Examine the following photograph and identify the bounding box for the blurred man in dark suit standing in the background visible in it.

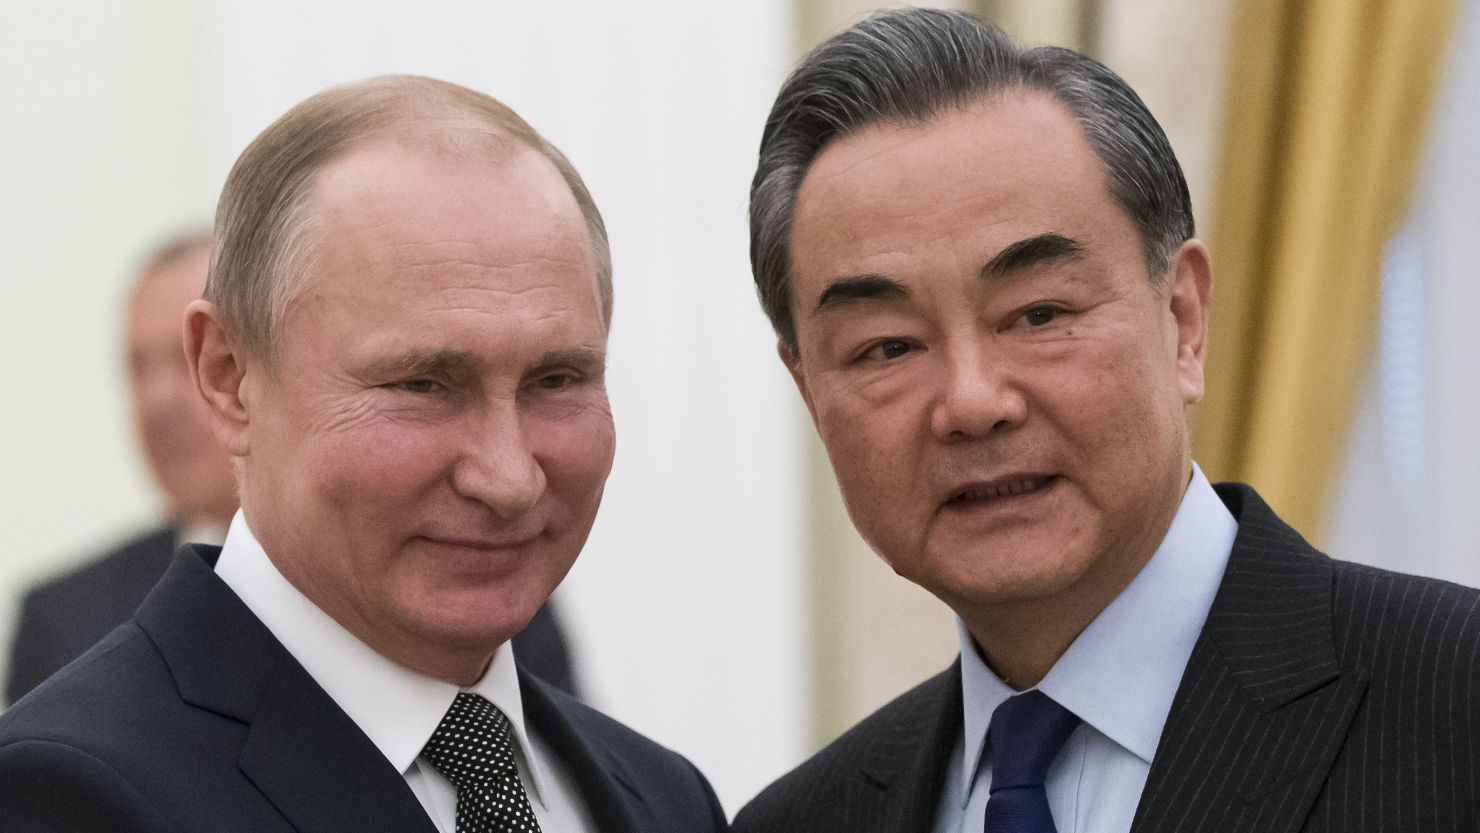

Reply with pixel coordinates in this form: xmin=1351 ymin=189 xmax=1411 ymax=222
xmin=4 ymin=234 xmax=576 ymax=703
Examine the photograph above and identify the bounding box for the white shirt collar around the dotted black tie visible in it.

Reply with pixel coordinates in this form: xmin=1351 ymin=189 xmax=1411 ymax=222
xmin=216 ymin=510 xmax=552 ymax=806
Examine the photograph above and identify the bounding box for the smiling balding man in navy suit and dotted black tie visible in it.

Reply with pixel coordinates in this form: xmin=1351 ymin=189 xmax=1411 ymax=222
xmin=0 ymin=77 xmax=725 ymax=833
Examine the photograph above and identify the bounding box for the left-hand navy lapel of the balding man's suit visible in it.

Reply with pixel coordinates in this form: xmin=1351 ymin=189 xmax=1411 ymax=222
xmin=138 ymin=547 xmax=435 ymax=833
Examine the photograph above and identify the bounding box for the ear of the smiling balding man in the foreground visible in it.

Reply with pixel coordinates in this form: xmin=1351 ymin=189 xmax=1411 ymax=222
xmin=185 ymin=300 xmax=249 ymax=457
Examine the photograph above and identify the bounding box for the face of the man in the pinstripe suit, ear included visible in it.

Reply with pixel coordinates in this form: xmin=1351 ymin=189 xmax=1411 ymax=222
xmin=783 ymin=93 xmax=1209 ymax=620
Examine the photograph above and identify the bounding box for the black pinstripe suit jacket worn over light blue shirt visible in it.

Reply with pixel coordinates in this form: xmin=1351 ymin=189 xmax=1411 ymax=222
xmin=734 ymin=484 xmax=1480 ymax=833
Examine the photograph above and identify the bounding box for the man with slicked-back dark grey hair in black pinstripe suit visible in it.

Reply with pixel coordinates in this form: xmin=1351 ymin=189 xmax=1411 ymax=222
xmin=734 ymin=9 xmax=1480 ymax=833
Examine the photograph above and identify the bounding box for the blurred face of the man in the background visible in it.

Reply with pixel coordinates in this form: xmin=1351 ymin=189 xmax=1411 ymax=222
xmin=126 ymin=247 xmax=237 ymax=524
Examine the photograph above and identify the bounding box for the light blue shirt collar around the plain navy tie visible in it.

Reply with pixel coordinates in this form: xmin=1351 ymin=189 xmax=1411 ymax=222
xmin=958 ymin=463 xmax=1239 ymax=795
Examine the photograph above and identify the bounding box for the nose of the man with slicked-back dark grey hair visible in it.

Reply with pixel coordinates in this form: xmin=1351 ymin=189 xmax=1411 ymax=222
xmin=931 ymin=343 xmax=1027 ymax=442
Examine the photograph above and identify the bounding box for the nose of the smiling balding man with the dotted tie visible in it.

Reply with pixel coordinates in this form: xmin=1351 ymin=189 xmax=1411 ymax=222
xmin=453 ymin=401 xmax=545 ymax=519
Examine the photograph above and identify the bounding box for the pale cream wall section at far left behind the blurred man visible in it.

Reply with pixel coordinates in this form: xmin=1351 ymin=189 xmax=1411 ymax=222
xmin=0 ymin=0 xmax=212 ymax=673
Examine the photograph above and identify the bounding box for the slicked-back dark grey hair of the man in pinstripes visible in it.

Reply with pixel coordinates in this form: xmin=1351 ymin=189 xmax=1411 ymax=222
xmin=750 ymin=9 xmax=1193 ymax=349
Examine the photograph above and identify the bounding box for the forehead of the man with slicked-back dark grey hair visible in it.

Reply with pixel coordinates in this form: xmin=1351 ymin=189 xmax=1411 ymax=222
xmin=792 ymin=90 xmax=1125 ymax=280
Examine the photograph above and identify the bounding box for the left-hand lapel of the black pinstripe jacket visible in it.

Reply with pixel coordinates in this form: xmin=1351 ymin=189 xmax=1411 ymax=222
xmin=842 ymin=660 xmax=962 ymax=833
